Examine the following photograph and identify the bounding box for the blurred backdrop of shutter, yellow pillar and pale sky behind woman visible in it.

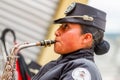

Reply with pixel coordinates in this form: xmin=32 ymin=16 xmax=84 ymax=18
xmin=0 ymin=0 xmax=120 ymax=80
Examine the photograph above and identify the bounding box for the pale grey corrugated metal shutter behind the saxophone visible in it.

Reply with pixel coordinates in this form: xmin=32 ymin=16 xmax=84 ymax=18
xmin=0 ymin=0 xmax=59 ymax=60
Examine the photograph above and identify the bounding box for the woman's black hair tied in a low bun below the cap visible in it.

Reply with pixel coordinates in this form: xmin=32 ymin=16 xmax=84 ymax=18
xmin=80 ymin=24 xmax=110 ymax=55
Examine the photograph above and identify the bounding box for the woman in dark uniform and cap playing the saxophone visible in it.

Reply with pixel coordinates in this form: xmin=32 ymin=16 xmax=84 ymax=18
xmin=32 ymin=2 xmax=110 ymax=80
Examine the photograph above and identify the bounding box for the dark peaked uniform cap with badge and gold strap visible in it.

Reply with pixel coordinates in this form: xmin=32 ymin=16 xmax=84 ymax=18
xmin=54 ymin=3 xmax=106 ymax=31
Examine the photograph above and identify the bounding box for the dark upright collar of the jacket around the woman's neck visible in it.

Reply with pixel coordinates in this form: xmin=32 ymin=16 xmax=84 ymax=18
xmin=57 ymin=49 xmax=94 ymax=63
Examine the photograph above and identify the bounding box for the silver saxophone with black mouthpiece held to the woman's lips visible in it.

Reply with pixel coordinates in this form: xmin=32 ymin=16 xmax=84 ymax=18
xmin=0 ymin=40 xmax=55 ymax=80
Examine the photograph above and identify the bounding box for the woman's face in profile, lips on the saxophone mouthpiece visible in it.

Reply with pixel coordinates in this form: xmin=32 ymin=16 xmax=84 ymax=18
xmin=54 ymin=23 xmax=88 ymax=54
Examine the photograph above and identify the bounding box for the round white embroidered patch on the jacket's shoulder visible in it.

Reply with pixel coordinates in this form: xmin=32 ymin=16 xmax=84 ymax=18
xmin=72 ymin=68 xmax=91 ymax=80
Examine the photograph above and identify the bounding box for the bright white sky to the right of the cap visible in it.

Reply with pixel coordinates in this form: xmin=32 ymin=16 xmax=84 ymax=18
xmin=88 ymin=0 xmax=120 ymax=34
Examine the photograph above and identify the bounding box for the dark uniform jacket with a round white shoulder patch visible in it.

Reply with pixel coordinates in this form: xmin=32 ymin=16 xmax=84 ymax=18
xmin=32 ymin=49 xmax=102 ymax=80
